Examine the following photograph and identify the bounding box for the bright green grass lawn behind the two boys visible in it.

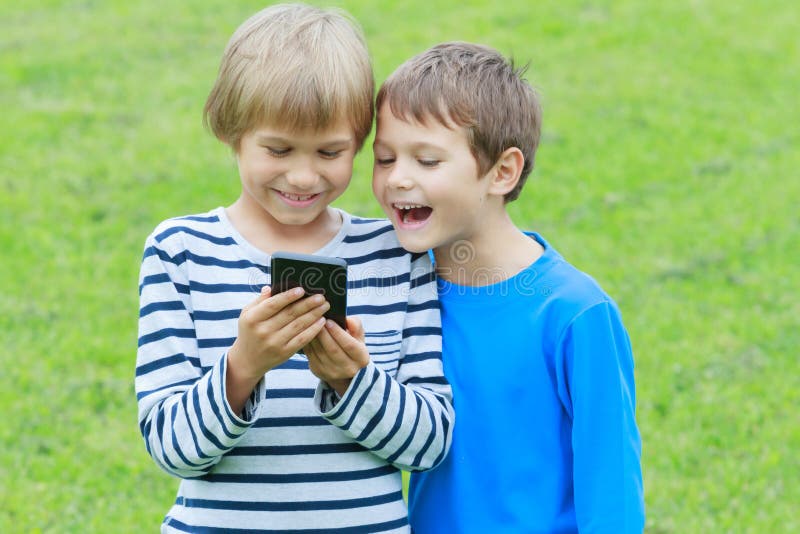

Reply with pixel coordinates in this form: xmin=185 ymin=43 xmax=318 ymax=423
xmin=0 ymin=0 xmax=800 ymax=534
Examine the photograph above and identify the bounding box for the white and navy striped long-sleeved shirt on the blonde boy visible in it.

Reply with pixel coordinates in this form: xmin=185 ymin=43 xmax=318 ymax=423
xmin=136 ymin=208 xmax=454 ymax=533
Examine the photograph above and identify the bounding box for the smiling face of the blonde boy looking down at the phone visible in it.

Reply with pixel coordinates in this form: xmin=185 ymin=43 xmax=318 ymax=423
xmin=236 ymin=121 xmax=356 ymax=231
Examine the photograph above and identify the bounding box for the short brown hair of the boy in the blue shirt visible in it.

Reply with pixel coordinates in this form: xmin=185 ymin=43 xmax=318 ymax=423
xmin=376 ymin=42 xmax=542 ymax=202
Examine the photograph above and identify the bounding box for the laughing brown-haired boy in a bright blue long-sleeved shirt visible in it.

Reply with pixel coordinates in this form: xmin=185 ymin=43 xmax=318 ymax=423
xmin=373 ymin=43 xmax=644 ymax=534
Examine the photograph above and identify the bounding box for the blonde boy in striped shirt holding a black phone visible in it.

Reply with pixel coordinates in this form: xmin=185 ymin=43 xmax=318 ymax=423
xmin=136 ymin=4 xmax=453 ymax=532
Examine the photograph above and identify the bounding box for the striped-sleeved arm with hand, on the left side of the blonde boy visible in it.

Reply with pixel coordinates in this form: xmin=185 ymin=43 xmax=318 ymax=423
xmin=136 ymin=238 xmax=327 ymax=477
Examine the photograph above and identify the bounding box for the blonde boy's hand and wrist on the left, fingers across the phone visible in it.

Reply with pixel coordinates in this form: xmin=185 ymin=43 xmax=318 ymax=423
xmin=226 ymin=286 xmax=330 ymax=413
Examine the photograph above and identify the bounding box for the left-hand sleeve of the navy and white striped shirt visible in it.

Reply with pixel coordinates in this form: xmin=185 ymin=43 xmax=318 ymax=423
xmin=135 ymin=236 xmax=258 ymax=478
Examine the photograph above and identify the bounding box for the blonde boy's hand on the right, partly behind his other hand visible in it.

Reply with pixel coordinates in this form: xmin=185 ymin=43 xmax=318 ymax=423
xmin=303 ymin=317 xmax=369 ymax=396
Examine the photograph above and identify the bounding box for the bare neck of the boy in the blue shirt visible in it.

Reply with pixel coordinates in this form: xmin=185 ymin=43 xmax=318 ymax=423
xmin=433 ymin=209 xmax=544 ymax=286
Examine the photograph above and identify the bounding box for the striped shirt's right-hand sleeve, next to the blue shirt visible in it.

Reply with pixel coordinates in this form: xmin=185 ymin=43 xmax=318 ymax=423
xmin=315 ymin=255 xmax=455 ymax=471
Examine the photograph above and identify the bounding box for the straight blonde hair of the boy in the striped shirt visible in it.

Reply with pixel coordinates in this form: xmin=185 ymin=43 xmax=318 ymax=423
xmin=203 ymin=4 xmax=375 ymax=149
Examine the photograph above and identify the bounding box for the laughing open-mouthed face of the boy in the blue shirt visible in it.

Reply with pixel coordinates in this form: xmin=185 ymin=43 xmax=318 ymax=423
xmin=372 ymin=104 xmax=491 ymax=252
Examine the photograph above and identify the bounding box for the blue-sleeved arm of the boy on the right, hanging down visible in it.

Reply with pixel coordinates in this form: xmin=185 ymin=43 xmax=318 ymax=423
xmin=559 ymin=302 xmax=644 ymax=534
